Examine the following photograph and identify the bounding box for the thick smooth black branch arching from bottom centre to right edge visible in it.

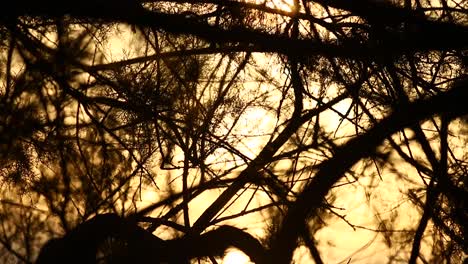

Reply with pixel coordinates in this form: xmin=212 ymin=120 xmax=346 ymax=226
xmin=270 ymin=77 xmax=468 ymax=263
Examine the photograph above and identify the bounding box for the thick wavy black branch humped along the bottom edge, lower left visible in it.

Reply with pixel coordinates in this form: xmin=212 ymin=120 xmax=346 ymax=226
xmin=36 ymin=214 xmax=266 ymax=264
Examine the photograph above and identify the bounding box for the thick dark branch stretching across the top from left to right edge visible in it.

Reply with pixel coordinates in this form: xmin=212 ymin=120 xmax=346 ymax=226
xmin=2 ymin=0 xmax=468 ymax=60
